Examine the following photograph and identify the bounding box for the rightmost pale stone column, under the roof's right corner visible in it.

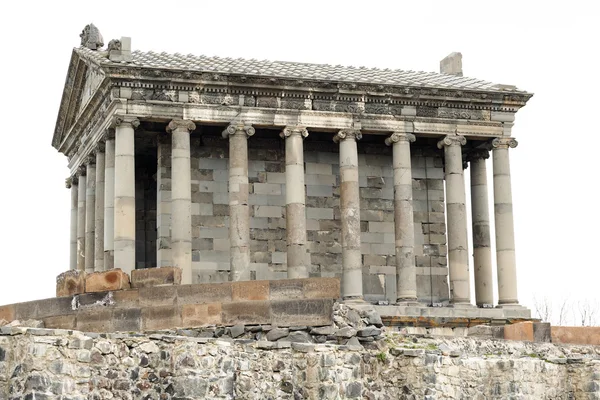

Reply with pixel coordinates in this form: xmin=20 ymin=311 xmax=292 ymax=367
xmin=492 ymin=137 xmax=519 ymax=306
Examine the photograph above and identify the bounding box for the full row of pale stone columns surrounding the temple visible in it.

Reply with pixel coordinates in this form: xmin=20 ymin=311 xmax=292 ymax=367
xmin=67 ymin=116 xmax=518 ymax=306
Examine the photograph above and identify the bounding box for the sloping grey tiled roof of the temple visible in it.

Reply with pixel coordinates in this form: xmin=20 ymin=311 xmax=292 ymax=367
xmin=75 ymin=47 xmax=526 ymax=93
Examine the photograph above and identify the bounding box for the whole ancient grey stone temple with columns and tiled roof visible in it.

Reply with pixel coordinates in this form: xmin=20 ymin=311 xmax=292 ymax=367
xmin=52 ymin=25 xmax=532 ymax=318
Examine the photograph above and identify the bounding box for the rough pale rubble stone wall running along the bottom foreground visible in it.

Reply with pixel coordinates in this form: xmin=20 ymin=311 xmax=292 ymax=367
xmin=0 ymin=327 xmax=600 ymax=400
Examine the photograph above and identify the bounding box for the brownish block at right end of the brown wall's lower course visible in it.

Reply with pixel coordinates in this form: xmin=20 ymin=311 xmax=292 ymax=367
xmin=271 ymin=299 xmax=334 ymax=326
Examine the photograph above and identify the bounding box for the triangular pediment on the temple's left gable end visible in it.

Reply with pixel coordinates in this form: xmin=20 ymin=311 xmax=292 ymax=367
xmin=52 ymin=50 xmax=105 ymax=151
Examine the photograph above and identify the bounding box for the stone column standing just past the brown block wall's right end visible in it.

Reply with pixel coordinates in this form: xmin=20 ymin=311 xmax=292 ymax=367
xmin=333 ymin=129 xmax=363 ymax=300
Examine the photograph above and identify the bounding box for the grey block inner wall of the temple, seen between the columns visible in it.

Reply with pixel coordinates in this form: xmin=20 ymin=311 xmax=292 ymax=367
xmin=157 ymin=127 xmax=449 ymax=303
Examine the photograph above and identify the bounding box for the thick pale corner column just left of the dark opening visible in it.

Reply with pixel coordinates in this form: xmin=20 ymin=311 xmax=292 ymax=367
xmin=114 ymin=116 xmax=140 ymax=274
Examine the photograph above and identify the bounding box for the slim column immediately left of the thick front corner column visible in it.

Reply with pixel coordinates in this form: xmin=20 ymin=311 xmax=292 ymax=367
xmin=104 ymin=128 xmax=115 ymax=271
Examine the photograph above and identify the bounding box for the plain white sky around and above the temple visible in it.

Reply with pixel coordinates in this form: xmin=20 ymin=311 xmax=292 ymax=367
xmin=0 ymin=0 xmax=600 ymax=324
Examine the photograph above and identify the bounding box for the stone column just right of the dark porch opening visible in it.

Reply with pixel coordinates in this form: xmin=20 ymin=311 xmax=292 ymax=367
xmin=167 ymin=119 xmax=196 ymax=284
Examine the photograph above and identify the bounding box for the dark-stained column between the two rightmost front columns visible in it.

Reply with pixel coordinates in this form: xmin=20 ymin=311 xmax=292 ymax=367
xmin=468 ymin=149 xmax=494 ymax=307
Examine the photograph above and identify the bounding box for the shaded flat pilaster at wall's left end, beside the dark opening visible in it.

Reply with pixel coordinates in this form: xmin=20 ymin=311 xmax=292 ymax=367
xmin=156 ymin=132 xmax=173 ymax=267
